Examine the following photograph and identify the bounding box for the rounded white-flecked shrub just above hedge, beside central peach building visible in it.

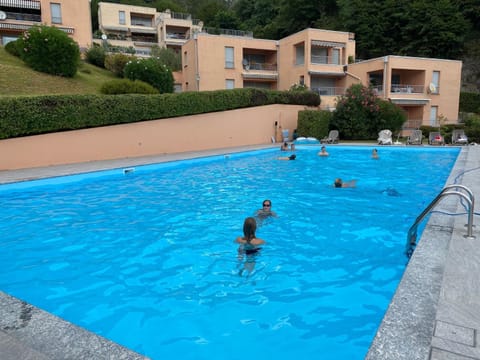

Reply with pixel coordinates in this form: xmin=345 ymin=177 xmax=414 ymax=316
xmin=124 ymin=58 xmax=173 ymax=94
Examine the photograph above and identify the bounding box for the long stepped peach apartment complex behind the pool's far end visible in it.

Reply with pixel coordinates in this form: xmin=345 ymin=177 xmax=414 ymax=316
xmin=182 ymin=29 xmax=462 ymax=128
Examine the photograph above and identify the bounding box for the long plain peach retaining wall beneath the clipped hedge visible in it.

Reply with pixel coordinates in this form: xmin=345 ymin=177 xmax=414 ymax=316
xmin=0 ymin=105 xmax=305 ymax=170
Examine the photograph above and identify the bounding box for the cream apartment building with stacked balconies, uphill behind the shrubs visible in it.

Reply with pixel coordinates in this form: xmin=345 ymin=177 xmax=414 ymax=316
xmin=94 ymin=2 xmax=203 ymax=56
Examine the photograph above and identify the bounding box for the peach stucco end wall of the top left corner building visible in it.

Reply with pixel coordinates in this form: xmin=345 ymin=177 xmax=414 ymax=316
xmin=40 ymin=0 xmax=92 ymax=48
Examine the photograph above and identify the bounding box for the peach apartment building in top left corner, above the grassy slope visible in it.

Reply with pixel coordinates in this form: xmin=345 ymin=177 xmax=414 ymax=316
xmin=0 ymin=0 xmax=92 ymax=49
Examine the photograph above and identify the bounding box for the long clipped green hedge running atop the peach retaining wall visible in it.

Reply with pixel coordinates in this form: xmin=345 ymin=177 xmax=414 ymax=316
xmin=0 ymin=89 xmax=320 ymax=139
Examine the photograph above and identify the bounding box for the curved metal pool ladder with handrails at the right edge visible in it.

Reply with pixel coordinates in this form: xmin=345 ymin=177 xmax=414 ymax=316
xmin=405 ymin=185 xmax=475 ymax=258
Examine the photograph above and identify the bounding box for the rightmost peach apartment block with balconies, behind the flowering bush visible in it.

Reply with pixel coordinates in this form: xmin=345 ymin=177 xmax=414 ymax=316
xmin=346 ymin=55 xmax=462 ymax=129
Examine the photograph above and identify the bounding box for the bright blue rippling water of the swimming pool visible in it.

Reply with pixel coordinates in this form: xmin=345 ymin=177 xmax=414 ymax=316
xmin=0 ymin=146 xmax=459 ymax=360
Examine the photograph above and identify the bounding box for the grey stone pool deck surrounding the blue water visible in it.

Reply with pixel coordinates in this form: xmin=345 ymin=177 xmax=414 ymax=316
xmin=0 ymin=144 xmax=480 ymax=360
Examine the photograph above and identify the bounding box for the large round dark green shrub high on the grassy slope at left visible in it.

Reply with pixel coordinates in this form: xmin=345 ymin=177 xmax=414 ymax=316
xmin=17 ymin=25 xmax=80 ymax=77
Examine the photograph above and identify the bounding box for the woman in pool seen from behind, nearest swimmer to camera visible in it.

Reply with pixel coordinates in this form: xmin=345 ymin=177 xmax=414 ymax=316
xmin=235 ymin=217 xmax=265 ymax=275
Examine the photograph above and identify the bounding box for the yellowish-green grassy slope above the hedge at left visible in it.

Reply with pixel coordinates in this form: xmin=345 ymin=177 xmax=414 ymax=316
xmin=0 ymin=46 xmax=115 ymax=96
